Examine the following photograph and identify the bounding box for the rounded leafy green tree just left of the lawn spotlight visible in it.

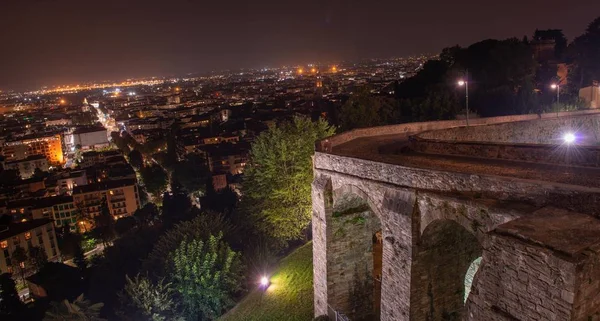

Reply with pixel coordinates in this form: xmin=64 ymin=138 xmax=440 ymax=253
xmin=170 ymin=234 xmax=241 ymax=320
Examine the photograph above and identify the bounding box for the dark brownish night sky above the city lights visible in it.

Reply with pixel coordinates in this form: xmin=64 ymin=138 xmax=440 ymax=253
xmin=0 ymin=0 xmax=600 ymax=89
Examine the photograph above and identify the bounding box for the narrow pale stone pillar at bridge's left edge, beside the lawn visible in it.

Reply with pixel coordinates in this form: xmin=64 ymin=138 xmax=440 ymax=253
xmin=312 ymin=176 xmax=332 ymax=317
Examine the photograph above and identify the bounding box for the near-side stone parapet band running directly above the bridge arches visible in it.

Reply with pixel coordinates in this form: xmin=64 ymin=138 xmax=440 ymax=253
xmin=314 ymin=152 xmax=600 ymax=216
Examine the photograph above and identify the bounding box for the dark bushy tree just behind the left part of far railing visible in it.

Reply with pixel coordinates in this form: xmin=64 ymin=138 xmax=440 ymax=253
xmin=339 ymin=87 xmax=400 ymax=130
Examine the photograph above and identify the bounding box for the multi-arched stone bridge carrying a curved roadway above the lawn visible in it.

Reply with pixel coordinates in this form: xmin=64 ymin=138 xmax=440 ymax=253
xmin=312 ymin=111 xmax=600 ymax=321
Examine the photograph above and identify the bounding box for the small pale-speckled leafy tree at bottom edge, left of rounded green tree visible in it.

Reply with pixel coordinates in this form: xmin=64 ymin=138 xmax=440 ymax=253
xmin=117 ymin=274 xmax=183 ymax=321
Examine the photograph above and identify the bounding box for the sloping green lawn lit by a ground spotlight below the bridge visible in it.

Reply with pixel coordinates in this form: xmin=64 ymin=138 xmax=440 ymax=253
xmin=219 ymin=242 xmax=313 ymax=321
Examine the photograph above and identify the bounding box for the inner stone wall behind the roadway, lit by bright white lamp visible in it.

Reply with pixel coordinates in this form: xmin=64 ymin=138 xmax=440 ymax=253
xmin=418 ymin=114 xmax=600 ymax=145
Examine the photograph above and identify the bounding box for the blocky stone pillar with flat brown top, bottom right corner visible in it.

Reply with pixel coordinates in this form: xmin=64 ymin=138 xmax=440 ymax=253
xmin=467 ymin=209 xmax=600 ymax=321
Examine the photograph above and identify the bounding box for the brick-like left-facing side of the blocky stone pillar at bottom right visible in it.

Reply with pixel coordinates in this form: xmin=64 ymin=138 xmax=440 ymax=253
xmin=467 ymin=231 xmax=575 ymax=321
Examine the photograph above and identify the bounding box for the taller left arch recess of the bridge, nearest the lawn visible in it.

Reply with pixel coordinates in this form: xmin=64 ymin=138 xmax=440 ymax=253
xmin=327 ymin=185 xmax=383 ymax=320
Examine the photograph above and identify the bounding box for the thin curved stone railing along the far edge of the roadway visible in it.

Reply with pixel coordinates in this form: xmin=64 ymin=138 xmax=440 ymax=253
xmin=315 ymin=109 xmax=600 ymax=153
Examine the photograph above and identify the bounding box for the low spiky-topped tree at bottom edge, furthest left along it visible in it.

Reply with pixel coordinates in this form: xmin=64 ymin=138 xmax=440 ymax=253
xmin=44 ymin=294 xmax=104 ymax=321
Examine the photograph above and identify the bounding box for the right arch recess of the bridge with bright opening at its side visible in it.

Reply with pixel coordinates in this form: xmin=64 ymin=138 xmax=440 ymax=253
xmin=410 ymin=219 xmax=482 ymax=321
